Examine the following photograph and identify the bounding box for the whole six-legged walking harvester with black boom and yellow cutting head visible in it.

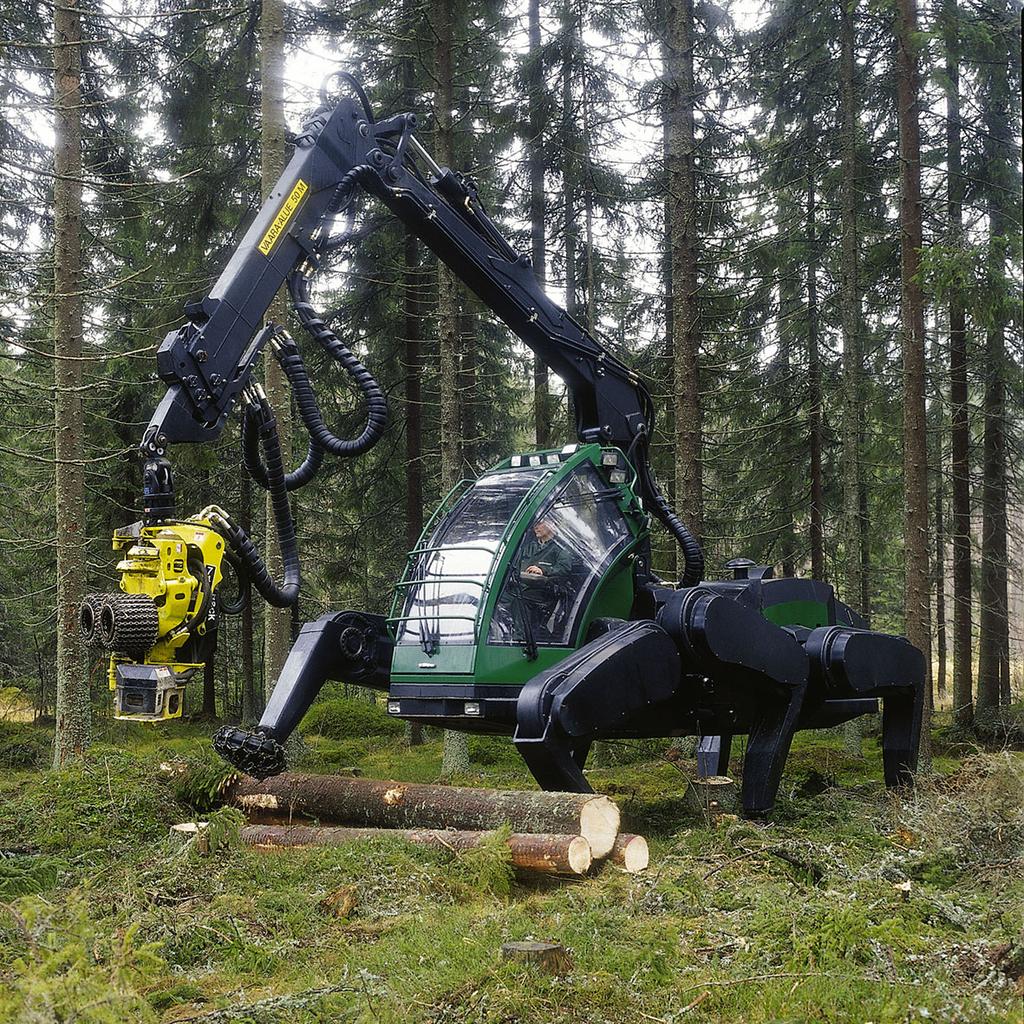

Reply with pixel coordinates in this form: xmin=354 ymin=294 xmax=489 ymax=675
xmin=81 ymin=73 xmax=925 ymax=816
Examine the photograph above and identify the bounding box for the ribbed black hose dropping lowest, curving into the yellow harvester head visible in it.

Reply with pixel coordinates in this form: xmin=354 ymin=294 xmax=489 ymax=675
xmin=218 ymin=394 xmax=301 ymax=608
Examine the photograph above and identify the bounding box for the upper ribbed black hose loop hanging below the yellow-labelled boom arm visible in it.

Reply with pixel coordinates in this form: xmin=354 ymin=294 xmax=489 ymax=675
xmin=278 ymin=270 xmax=387 ymax=456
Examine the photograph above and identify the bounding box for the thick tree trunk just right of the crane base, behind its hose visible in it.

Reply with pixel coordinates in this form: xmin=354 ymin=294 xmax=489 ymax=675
xmin=666 ymin=0 xmax=703 ymax=574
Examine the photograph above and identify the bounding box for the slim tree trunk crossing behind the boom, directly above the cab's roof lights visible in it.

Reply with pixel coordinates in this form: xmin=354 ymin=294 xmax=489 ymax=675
xmin=526 ymin=0 xmax=552 ymax=449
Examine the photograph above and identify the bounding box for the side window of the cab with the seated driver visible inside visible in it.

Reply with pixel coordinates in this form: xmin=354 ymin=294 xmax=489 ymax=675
xmin=487 ymin=463 xmax=632 ymax=646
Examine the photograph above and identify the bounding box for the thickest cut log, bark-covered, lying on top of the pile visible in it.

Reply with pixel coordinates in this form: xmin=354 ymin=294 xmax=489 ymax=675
xmin=224 ymin=773 xmax=618 ymax=857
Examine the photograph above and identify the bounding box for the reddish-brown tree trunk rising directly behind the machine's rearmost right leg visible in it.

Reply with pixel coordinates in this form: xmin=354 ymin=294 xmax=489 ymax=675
xmin=896 ymin=0 xmax=932 ymax=771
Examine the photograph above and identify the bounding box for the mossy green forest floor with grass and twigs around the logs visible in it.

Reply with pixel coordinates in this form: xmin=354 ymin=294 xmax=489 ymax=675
xmin=0 ymin=725 xmax=1024 ymax=1024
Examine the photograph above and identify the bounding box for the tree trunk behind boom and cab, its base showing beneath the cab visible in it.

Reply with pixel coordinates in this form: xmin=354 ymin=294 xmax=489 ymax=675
xmin=430 ymin=0 xmax=469 ymax=777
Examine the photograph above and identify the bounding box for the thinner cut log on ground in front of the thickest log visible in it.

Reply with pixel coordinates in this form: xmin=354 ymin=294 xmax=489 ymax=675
xmin=242 ymin=825 xmax=592 ymax=874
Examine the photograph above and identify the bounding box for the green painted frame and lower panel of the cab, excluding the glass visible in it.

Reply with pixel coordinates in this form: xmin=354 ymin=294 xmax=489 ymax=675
xmin=391 ymin=444 xmax=649 ymax=685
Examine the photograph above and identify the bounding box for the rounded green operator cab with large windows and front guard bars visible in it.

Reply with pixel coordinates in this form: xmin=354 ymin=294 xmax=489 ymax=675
xmin=388 ymin=444 xmax=649 ymax=732
